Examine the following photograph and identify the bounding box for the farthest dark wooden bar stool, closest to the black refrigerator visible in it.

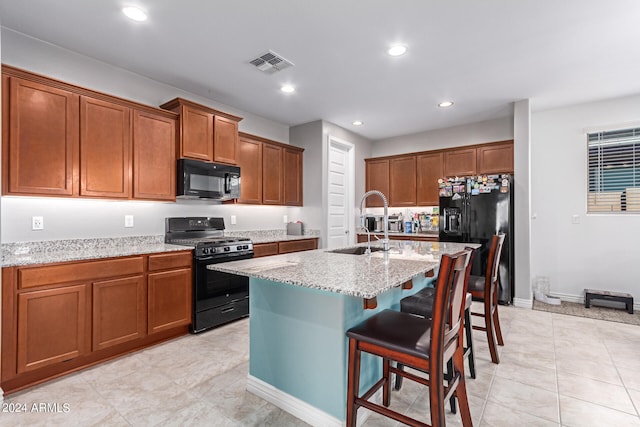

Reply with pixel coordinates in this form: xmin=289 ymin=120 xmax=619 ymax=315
xmin=468 ymin=234 xmax=505 ymax=363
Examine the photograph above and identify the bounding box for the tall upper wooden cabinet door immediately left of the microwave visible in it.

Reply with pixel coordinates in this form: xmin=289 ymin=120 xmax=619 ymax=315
xmin=133 ymin=110 xmax=176 ymax=201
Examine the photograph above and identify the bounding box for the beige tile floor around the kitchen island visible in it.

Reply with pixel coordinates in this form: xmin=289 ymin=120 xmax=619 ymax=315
xmin=0 ymin=307 xmax=640 ymax=427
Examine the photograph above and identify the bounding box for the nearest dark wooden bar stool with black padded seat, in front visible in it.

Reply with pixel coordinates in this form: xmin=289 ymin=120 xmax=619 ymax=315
xmin=346 ymin=251 xmax=472 ymax=427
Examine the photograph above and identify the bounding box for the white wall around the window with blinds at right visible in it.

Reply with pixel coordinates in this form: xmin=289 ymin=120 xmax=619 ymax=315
xmin=531 ymin=95 xmax=640 ymax=301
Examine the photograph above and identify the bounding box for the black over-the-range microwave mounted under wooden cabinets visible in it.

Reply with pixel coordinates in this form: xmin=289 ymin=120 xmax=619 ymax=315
xmin=176 ymin=159 xmax=240 ymax=201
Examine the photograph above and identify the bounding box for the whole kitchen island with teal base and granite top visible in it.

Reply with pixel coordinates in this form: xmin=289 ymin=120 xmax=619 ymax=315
xmin=208 ymin=241 xmax=476 ymax=426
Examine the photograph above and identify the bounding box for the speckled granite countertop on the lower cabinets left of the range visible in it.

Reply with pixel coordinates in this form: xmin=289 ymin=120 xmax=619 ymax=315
xmin=1 ymin=236 xmax=191 ymax=267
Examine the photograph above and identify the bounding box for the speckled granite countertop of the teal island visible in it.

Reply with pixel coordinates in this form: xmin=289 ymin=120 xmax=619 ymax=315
xmin=207 ymin=241 xmax=479 ymax=298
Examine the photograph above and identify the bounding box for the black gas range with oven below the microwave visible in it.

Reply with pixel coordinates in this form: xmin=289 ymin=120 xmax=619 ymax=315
xmin=164 ymin=217 xmax=253 ymax=333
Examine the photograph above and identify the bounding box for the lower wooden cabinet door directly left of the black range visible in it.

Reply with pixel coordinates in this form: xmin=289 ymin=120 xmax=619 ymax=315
xmin=147 ymin=268 xmax=193 ymax=334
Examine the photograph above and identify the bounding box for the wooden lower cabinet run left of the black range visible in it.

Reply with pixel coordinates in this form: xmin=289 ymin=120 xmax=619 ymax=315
xmin=0 ymin=250 xmax=193 ymax=393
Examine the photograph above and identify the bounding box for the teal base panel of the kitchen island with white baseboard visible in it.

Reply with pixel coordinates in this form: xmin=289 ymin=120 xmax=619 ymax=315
xmin=247 ymin=276 xmax=433 ymax=426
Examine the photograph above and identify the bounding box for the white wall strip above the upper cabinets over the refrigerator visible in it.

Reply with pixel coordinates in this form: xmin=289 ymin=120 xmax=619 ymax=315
xmin=371 ymin=117 xmax=513 ymax=157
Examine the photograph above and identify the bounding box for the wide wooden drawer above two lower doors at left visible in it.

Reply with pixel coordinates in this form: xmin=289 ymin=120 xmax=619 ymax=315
xmin=18 ymin=257 xmax=144 ymax=289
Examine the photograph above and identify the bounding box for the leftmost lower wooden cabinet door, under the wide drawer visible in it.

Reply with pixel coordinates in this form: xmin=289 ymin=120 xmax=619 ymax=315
xmin=17 ymin=285 xmax=90 ymax=373
